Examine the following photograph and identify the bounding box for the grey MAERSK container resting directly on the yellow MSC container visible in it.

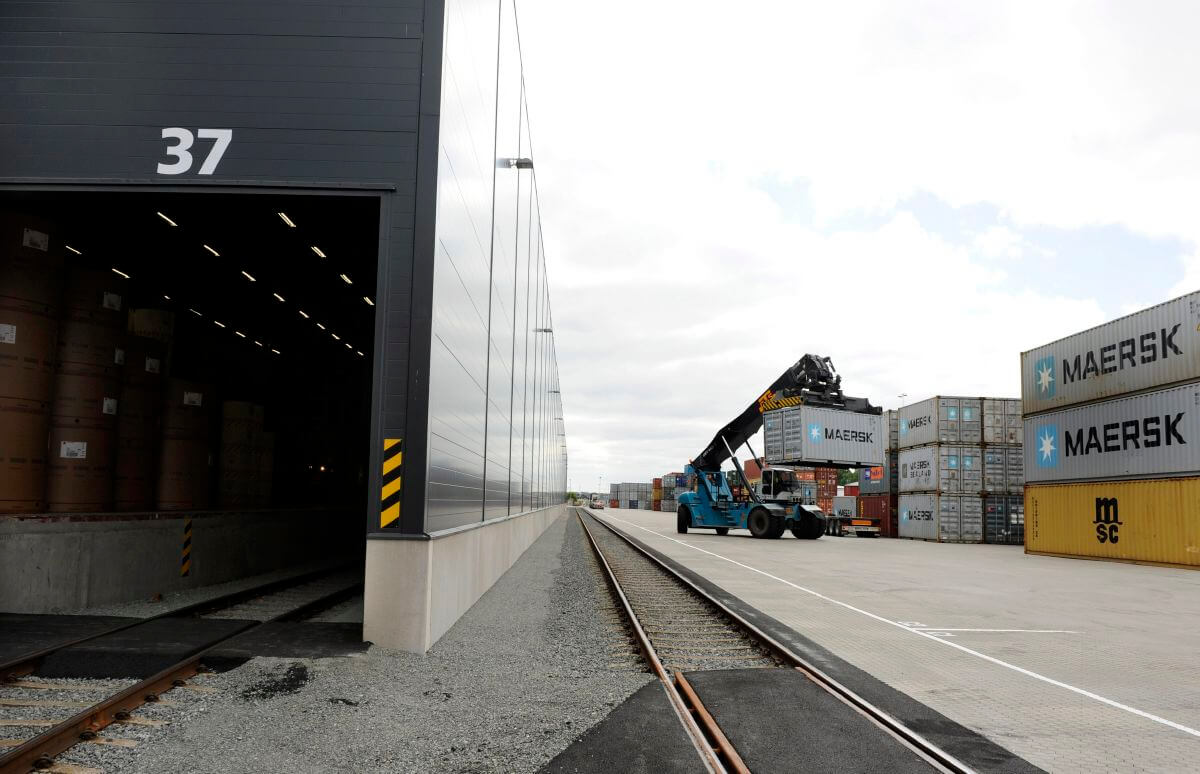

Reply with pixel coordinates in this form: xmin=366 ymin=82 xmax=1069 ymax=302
xmin=1025 ymin=382 xmax=1200 ymax=484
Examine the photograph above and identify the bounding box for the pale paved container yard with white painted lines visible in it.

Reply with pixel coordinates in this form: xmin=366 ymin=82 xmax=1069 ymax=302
xmin=596 ymin=510 xmax=1200 ymax=772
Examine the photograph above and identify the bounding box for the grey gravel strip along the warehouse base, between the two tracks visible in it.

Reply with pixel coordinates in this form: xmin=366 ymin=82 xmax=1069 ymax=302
xmin=110 ymin=516 xmax=652 ymax=774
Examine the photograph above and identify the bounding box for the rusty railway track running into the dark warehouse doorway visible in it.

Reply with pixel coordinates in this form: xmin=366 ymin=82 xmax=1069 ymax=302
xmin=0 ymin=568 xmax=362 ymax=774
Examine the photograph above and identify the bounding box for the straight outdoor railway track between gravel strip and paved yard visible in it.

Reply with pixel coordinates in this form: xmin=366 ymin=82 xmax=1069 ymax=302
xmin=576 ymin=509 xmax=972 ymax=774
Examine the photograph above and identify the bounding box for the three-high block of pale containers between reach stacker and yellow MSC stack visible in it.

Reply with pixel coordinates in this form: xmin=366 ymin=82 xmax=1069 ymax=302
xmin=895 ymin=395 xmax=1024 ymax=544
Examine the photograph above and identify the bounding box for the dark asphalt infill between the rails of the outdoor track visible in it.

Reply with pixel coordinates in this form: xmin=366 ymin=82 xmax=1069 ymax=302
xmin=684 ymin=670 xmax=935 ymax=774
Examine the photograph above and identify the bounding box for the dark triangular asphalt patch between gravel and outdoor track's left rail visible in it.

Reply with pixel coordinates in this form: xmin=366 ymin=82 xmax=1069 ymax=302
xmin=541 ymin=680 xmax=704 ymax=774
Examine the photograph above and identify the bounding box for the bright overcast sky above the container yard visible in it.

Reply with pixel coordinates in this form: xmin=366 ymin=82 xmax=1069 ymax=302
xmin=518 ymin=0 xmax=1200 ymax=491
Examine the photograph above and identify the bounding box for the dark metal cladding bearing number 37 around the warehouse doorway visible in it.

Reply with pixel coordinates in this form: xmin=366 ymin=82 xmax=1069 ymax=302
xmin=0 ymin=0 xmax=427 ymax=534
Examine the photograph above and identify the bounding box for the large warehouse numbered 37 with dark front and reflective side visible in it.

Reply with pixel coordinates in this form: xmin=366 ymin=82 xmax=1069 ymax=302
xmin=0 ymin=0 xmax=566 ymax=652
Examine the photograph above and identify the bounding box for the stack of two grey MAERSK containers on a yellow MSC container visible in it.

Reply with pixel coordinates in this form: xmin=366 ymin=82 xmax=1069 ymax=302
xmin=1021 ymin=292 xmax=1200 ymax=568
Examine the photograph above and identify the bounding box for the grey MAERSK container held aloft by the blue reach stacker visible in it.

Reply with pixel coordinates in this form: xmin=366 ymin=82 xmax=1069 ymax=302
xmin=762 ymin=406 xmax=887 ymax=468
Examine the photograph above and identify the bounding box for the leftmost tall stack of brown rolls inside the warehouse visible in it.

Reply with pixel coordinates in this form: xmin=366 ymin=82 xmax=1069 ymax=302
xmin=0 ymin=214 xmax=64 ymax=512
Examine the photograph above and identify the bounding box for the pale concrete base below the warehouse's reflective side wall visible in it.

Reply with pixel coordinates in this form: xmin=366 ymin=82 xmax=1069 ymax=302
xmin=362 ymin=505 xmax=566 ymax=653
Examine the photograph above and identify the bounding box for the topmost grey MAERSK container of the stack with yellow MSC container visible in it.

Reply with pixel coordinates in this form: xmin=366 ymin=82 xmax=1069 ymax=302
xmin=1021 ymin=292 xmax=1200 ymax=416
